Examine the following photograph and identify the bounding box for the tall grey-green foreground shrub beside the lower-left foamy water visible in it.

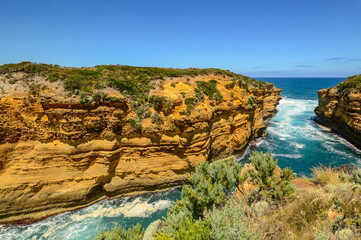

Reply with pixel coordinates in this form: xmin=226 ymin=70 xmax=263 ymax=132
xmin=162 ymin=161 xmax=244 ymax=237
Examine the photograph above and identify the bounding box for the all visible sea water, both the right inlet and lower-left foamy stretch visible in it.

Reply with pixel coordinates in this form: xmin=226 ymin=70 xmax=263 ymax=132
xmin=0 ymin=78 xmax=361 ymax=240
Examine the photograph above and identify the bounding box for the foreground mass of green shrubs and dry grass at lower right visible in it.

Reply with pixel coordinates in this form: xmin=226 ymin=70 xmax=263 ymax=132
xmin=91 ymin=152 xmax=361 ymax=240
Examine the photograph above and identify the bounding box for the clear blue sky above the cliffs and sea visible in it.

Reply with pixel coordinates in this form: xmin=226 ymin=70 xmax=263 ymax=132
xmin=0 ymin=0 xmax=361 ymax=77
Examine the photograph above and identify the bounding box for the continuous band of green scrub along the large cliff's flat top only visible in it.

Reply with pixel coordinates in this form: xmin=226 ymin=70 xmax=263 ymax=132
xmin=0 ymin=62 xmax=265 ymax=98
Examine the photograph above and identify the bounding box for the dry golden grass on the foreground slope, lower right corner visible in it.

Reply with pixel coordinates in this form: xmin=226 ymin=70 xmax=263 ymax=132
xmin=250 ymin=166 xmax=361 ymax=240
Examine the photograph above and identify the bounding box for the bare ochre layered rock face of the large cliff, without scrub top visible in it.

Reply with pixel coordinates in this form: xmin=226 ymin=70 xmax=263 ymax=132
xmin=0 ymin=63 xmax=281 ymax=222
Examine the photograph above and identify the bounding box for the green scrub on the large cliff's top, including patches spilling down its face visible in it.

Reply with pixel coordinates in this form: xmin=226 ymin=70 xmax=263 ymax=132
xmin=0 ymin=62 xmax=272 ymax=124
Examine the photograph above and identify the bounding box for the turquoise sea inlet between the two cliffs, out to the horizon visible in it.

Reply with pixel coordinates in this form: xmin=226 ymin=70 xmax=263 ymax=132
xmin=243 ymin=78 xmax=361 ymax=176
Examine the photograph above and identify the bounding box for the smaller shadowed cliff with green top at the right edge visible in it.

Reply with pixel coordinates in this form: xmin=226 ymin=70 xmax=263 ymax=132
xmin=315 ymin=75 xmax=361 ymax=148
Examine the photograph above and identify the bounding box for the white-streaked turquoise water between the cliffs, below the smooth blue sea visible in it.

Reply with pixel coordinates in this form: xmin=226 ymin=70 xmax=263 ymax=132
xmin=242 ymin=98 xmax=361 ymax=175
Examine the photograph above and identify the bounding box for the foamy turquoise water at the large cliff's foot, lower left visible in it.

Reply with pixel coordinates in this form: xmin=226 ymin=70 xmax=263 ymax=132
xmin=0 ymin=188 xmax=180 ymax=240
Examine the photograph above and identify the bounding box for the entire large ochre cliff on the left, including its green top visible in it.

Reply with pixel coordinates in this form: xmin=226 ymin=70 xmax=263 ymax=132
xmin=0 ymin=62 xmax=281 ymax=222
